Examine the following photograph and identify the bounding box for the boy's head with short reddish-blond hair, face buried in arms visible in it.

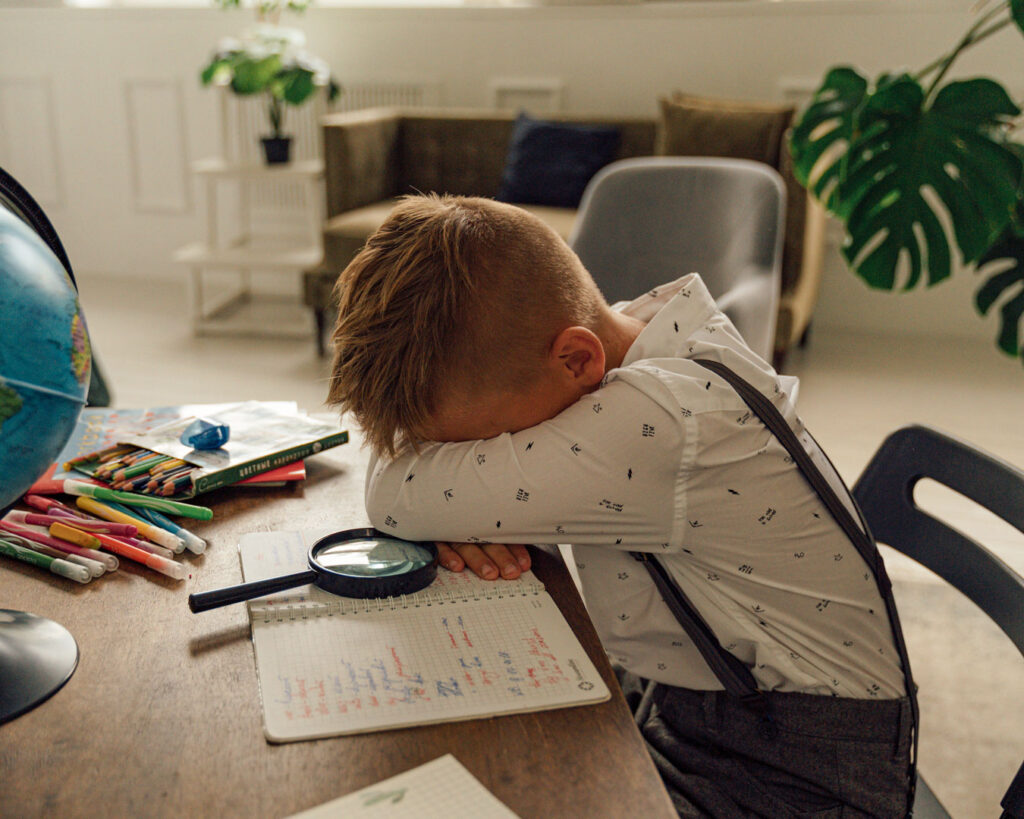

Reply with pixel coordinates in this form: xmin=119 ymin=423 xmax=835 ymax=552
xmin=328 ymin=195 xmax=608 ymax=455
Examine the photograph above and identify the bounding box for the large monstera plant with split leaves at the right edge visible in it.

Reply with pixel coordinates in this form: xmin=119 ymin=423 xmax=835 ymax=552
xmin=790 ymin=0 xmax=1024 ymax=361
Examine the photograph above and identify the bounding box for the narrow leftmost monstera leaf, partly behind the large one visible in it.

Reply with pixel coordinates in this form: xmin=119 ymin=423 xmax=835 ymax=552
xmin=790 ymin=67 xmax=867 ymax=210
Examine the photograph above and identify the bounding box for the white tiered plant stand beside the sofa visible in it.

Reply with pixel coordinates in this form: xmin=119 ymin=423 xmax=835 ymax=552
xmin=174 ymin=89 xmax=326 ymax=338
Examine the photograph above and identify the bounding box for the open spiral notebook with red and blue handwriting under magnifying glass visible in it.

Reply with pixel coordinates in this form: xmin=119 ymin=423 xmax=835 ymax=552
xmin=239 ymin=531 xmax=610 ymax=742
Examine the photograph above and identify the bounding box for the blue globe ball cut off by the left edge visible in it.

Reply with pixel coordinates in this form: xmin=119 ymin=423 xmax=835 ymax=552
xmin=0 ymin=200 xmax=92 ymax=510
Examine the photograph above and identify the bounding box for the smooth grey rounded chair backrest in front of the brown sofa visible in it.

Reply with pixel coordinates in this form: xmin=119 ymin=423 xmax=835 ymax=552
xmin=569 ymin=157 xmax=785 ymax=360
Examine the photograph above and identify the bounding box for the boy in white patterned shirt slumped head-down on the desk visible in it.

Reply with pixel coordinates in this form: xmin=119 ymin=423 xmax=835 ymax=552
xmin=329 ymin=196 xmax=913 ymax=817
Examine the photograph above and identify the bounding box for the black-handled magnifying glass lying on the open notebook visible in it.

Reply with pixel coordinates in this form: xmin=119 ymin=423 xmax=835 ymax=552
xmin=188 ymin=528 xmax=437 ymax=611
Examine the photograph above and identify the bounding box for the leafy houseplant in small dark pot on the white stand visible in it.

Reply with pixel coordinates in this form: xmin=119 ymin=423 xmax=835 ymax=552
xmin=200 ymin=0 xmax=340 ymax=164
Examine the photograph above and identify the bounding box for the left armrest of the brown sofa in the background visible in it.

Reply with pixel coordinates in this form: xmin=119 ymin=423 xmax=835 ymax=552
xmin=323 ymin=109 xmax=401 ymax=219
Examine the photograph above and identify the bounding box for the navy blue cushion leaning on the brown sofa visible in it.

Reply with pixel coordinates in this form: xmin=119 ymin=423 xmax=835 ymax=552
xmin=498 ymin=114 xmax=621 ymax=208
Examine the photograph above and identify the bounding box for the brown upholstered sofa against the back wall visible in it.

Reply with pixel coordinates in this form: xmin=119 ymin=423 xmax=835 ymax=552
xmin=303 ymin=100 xmax=824 ymax=365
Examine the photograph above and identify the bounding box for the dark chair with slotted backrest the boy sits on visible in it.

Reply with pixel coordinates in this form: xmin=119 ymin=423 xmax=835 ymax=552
xmin=853 ymin=426 xmax=1024 ymax=819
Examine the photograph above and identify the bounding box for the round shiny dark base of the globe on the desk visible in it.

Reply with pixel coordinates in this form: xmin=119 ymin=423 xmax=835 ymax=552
xmin=0 ymin=609 xmax=78 ymax=723
